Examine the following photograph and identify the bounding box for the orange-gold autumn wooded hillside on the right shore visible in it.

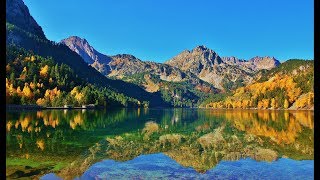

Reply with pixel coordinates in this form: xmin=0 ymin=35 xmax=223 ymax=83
xmin=201 ymin=59 xmax=314 ymax=109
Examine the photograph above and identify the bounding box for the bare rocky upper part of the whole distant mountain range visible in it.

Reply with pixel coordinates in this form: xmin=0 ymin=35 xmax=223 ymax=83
xmin=61 ymin=36 xmax=280 ymax=90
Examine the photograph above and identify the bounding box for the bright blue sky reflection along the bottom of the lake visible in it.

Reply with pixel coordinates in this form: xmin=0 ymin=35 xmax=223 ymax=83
xmin=41 ymin=153 xmax=314 ymax=180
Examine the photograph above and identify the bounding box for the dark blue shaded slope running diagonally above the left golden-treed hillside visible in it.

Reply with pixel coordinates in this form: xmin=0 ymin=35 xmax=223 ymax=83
xmin=6 ymin=0 xmax=166 ymax=106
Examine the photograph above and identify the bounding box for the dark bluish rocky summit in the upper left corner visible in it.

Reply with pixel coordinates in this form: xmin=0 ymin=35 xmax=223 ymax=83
xmin=6 ymin=0 xmax=45 ymax=38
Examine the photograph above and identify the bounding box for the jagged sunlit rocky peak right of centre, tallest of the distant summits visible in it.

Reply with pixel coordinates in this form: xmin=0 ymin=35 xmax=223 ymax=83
xmin=165 ymin=46 xmax=252 ymax=90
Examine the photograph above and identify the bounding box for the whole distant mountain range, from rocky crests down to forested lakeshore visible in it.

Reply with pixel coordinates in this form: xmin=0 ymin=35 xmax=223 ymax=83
xmin=61 ymin=36 xmax=280 ymax=105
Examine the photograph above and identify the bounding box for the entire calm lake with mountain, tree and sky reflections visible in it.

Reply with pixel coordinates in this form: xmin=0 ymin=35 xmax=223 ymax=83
xmin=6 ymin=108 xmax=314 ymax=179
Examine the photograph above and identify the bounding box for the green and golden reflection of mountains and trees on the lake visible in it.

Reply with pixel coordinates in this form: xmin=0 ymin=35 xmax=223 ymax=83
xmin=6 ymin=109 xmax=314 ymax=179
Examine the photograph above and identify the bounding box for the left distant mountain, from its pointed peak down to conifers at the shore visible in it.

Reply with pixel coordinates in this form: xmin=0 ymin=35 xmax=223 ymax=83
xmin=61 ymin=36 xmax=222 ymax=106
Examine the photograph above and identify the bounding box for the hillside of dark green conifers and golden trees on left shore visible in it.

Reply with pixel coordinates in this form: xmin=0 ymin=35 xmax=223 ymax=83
xmin=6 ymin=46 xmax=148 ymax=107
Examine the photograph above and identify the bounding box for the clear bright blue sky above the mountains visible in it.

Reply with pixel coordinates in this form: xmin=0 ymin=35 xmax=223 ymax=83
xmin=24 ymin=0 xmax=314 ymax=62
